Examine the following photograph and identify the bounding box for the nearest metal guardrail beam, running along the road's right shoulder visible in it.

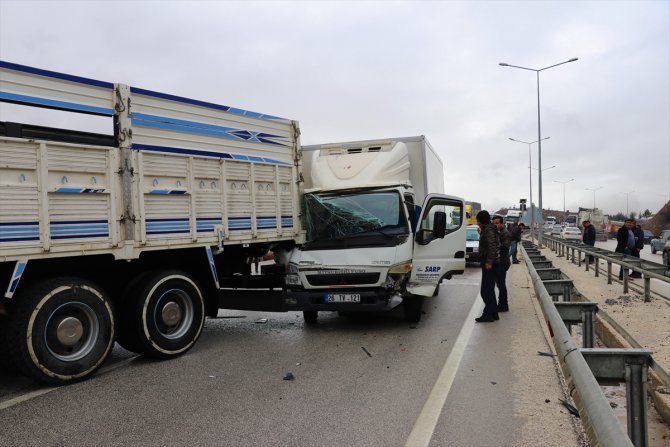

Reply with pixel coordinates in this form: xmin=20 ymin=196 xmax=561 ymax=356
xmin=520 ymin=244 xmax=633 ymax=447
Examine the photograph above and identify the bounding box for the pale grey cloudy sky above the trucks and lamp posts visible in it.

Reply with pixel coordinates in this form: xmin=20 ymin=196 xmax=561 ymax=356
xmin=0 ymin=0 xmax=670 ymax=217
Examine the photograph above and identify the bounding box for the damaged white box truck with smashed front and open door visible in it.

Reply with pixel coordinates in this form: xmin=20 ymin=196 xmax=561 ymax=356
xmin=276 ymin=136 xmax=466 ymax=322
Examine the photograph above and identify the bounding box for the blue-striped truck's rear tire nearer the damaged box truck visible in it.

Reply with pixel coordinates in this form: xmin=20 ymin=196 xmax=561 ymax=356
xmin=120 ymin=271 xmax=205 ymax=359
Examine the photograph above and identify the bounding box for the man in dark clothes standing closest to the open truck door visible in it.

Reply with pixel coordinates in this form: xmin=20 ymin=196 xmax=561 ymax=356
xmin=475 ymin=211 xmax=500 ymax=323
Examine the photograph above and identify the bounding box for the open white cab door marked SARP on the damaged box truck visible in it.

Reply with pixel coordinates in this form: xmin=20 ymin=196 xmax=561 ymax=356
xmin=407 ymin=194 xmax=466 ymax=296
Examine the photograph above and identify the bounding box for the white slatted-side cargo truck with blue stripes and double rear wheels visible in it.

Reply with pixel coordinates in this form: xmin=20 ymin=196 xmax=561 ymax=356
xmin=0 ymin=61 xmax=304 ymax=384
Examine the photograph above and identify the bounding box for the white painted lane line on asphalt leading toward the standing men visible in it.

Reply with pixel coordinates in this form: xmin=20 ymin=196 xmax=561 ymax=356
xmin=405 ymin=294 xmax=484 ymax=447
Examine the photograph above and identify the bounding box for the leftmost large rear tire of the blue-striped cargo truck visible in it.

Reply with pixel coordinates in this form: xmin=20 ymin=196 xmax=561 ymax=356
xmin=6 ymin=277 xmax=115 ymax=385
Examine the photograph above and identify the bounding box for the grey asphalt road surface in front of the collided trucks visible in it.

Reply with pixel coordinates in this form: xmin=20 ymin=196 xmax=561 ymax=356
xmin=0 ymin=268 xmax=571 ymax=446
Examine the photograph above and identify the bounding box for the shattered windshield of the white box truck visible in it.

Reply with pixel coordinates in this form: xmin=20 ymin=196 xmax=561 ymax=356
xmin=305 ymin=191 xmax=409 ymax=241
